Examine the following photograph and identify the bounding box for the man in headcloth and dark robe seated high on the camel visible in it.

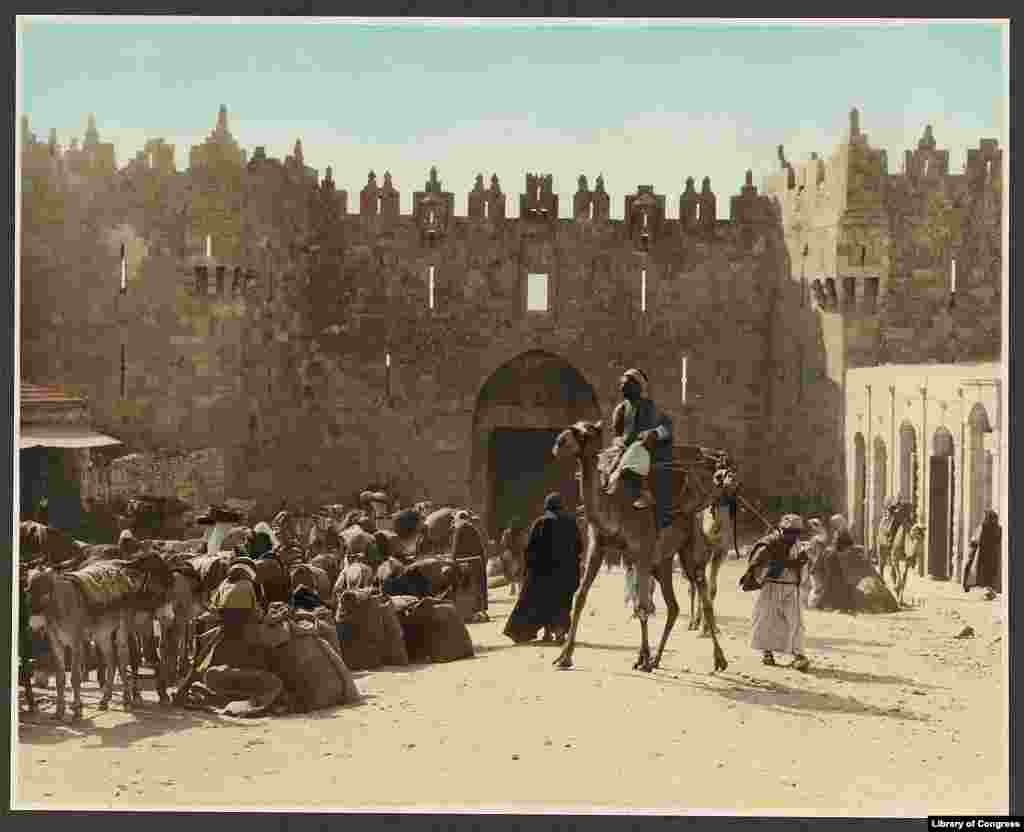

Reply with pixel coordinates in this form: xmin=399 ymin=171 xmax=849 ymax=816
xmin=611 ymin=369 xmax=672 ymax=529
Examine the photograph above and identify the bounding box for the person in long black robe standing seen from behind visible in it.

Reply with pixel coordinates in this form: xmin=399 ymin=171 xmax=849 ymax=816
xmin=505 ymin=493 xmax=583 ymax=643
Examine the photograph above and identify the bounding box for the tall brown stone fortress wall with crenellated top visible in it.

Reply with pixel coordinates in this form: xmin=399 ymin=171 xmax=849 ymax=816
xmin=22 ymin=108 xmax=999 ymax=532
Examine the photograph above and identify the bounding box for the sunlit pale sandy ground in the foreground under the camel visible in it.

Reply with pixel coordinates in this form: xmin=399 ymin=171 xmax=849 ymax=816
xmin=14 ymin=561 xmax=1008 ymax=816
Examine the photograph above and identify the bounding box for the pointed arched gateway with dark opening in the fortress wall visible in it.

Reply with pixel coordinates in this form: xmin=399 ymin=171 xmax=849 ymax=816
xmin=470 ymin=349 xmax=601 ymax=536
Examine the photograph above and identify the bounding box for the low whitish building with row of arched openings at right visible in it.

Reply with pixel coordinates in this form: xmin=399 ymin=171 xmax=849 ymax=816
xmin=845 ymin=363 xmax=1009 ymax=579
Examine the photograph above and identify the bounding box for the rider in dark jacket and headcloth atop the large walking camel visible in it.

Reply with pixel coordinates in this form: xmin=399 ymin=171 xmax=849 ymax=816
xmin=611 ymin=369 xmax=672 ymax=509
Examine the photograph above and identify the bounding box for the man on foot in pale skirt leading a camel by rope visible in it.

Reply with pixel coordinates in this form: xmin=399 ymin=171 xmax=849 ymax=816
xmin=739 ymin=514 xmax=811 ymax=670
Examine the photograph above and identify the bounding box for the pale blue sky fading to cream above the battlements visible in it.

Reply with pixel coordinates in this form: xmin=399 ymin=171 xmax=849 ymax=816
xmin=19 ymin=18 xmax=1008 ymax=217
